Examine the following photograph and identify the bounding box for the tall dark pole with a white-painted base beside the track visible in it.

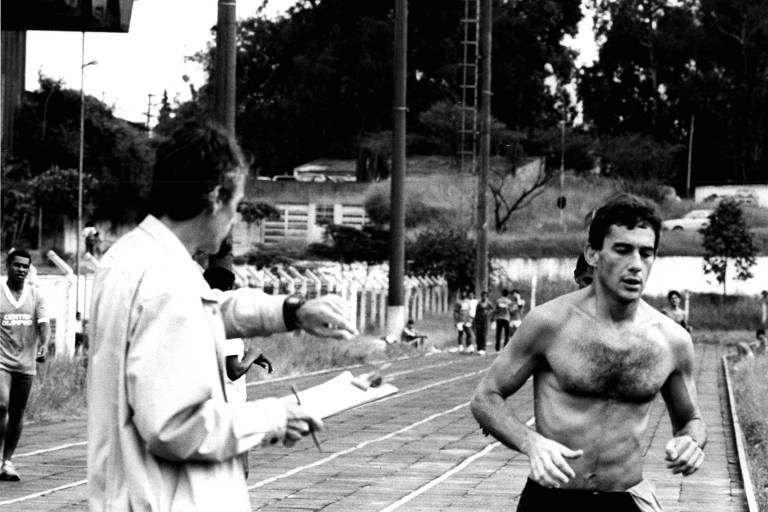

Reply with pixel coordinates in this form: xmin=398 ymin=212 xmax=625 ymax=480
xmin=387 ymin=0 xmax=408 ymax=339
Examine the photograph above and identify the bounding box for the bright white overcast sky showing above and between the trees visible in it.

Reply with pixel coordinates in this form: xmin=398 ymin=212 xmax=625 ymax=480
xmin=26 ymin=0 xmax=595 ymax=122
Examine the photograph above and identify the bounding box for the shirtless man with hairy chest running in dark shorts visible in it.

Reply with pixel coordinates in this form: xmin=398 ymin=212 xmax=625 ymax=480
xmin=472 ymin=194 xmax=706 ymax=511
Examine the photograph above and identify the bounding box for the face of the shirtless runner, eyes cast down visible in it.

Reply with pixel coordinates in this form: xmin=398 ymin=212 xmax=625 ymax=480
xmin=590 ymin=225 xmax=656 ymax=302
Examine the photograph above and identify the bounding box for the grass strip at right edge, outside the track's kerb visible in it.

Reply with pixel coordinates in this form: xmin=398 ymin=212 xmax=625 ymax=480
xmin=732 ymin=354 xmax=768 ymax=510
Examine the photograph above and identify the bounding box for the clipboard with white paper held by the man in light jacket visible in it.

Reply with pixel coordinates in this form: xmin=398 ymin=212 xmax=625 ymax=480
xmin=280 ymin=371 xmax=398 ymax=419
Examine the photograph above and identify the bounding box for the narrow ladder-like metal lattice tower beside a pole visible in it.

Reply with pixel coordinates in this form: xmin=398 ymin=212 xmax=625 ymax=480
xmin=459 ymin=0 xmax=480 ymax=174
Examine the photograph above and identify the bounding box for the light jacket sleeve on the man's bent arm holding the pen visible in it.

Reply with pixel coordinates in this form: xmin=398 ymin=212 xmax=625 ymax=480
xmin=125 ymin=292 xmax=286 ymax=461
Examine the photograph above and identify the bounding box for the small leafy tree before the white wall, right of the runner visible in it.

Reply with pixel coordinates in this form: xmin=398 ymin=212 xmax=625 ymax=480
xmin=701 ymin=199 xmax=757 ymax=298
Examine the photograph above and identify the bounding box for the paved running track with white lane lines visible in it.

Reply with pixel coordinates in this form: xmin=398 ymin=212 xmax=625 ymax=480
xmin=0 ymin=345 xmax=746 ymax=512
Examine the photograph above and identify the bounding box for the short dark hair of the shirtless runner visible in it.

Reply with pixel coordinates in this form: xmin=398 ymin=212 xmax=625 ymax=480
xmin=589 ymin=194 xmax=661 ymax=251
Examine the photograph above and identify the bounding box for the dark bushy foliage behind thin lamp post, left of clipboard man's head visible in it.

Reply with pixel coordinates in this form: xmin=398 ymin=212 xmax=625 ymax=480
xmin=13 ymin=77 xmax=152 ymax=222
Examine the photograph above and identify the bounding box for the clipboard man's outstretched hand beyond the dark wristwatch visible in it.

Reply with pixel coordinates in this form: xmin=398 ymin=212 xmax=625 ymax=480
xmin=296 ymin=295 xmax=360 ymax=340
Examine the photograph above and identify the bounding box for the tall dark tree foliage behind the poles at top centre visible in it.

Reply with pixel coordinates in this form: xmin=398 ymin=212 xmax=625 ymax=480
xmin=165 ymin=0 xmax=581 ymax=175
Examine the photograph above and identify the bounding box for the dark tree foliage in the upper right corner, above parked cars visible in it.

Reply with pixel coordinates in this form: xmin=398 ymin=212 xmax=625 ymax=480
xmin=579 ymin=0 xmax=768 ymax=185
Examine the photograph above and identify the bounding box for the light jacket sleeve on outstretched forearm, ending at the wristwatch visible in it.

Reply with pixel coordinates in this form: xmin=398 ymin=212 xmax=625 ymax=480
xmin=220 ymin=288 xmax=287 ymax=338
